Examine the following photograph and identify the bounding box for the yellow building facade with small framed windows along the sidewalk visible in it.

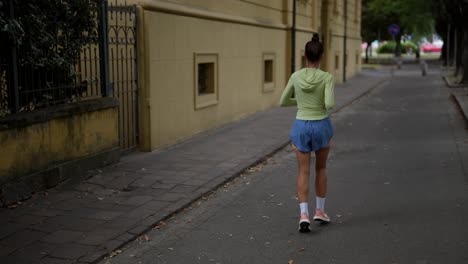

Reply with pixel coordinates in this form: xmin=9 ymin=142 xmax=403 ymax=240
xmin=133 ymin=0 xmax=361 ymax=151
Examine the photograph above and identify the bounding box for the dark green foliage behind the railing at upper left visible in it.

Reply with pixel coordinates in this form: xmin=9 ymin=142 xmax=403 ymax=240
xmin=0 ymin=0 xmax=99 ymax=110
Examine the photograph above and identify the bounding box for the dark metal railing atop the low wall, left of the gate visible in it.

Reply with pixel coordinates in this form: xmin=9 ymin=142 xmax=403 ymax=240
xmin=0 ymin=0 xmax=106 ymax=116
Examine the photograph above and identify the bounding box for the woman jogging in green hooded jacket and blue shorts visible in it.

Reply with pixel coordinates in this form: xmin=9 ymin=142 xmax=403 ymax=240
xmin=280 ymin=34 xmax=335 ymax=233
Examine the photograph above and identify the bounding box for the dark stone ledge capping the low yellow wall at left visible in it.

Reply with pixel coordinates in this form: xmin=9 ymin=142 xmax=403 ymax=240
xmin=0 ymin=97 xmax=118 ymax=131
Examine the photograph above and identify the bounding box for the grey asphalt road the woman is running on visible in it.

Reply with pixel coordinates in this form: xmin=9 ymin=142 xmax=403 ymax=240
xmin=102 ymin=66 xmax=468 ymax=264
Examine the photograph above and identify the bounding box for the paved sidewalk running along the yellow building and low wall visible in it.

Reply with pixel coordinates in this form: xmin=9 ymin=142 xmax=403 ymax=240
xmin=0 ymin=71 xmax=390 ymax=264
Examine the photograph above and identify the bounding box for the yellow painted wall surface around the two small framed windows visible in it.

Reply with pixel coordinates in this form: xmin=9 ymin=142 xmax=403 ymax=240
xmin=144 ymin=11 xmax=286 ymax=149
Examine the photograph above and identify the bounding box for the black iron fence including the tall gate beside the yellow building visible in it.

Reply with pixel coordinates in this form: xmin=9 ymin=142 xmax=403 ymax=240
xmin=0 ymin=0 xmax=138 ymax=148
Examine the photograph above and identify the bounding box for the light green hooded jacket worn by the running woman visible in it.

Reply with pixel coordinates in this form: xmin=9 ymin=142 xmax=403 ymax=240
xmin=280 ymin=68 xmax=335 ymax=120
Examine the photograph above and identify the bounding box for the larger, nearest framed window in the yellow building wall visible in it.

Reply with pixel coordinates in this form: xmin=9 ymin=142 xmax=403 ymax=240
xmin=194 ymin=53 xmax=218 ymax=109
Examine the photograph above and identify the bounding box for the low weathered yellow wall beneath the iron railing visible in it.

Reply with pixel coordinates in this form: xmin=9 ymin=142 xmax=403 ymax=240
xmin=0 ymin=103 xmax=118 ymax=182
